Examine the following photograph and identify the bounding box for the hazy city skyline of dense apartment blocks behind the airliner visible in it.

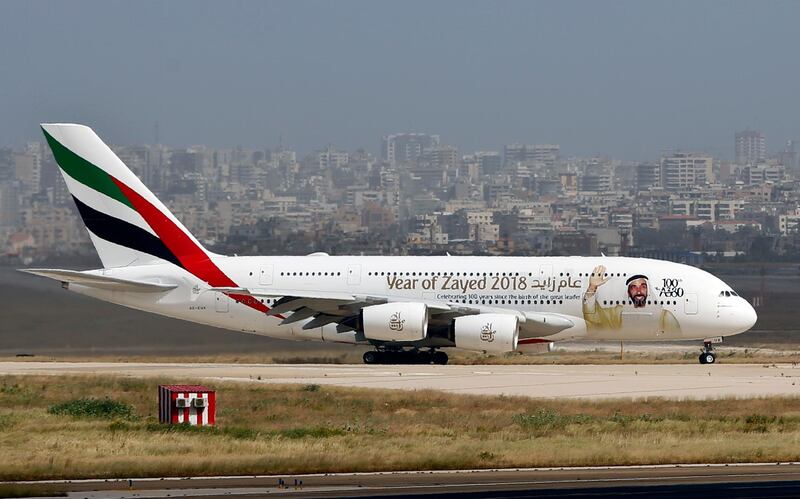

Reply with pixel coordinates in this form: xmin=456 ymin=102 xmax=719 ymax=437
xmin=0 ymin=120 xmax=800 ymax=262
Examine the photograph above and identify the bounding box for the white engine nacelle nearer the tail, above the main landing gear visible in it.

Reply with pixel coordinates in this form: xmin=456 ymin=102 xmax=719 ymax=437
xmin=361 ymin=302 xmax=428 ymax=341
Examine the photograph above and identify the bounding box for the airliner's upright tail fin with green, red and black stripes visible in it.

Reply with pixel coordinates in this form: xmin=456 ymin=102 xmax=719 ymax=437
xmin=41 ymin=123 xmax=209 ymax=269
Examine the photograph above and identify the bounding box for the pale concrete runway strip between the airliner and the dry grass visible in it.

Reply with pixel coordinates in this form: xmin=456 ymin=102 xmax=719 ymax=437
xmin=0 ymin=361 xmax=800 ymax=399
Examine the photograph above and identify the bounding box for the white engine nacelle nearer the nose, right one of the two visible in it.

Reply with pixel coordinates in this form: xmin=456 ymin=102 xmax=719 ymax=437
xmin=453 ymin=314 xmax=519 ymax=353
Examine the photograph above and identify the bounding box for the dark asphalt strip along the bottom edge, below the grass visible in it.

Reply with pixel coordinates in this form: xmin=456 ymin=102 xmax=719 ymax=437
xmin=12 ymin=463 xmax=800 ymax=499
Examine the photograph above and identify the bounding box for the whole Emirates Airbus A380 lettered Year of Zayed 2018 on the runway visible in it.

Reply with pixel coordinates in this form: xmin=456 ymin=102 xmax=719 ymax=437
xmin=20 ymin=124 xmax=756 ymax=364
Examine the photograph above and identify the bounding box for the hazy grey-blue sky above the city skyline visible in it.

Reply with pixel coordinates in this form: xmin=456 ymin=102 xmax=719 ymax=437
xmin=0 ymin=0 xmax=800 ymax=159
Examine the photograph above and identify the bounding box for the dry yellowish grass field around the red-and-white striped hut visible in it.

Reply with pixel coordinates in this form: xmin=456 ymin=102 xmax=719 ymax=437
xmin=0 ymin=376 xmax=800 ymax=479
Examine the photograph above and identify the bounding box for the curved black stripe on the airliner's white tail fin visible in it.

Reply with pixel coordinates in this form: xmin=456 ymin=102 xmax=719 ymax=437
xmin=72 ymin=196 xmax=182 ymax=267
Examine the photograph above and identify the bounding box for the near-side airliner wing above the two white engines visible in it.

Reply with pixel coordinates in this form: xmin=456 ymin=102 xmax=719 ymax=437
xmin=210 ymin=288 xmax=575 ymax=338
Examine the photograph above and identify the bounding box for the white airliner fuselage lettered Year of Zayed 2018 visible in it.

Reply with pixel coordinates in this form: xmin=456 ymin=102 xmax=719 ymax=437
xmin=69 ymin=255 xmax=756 ymax=349
